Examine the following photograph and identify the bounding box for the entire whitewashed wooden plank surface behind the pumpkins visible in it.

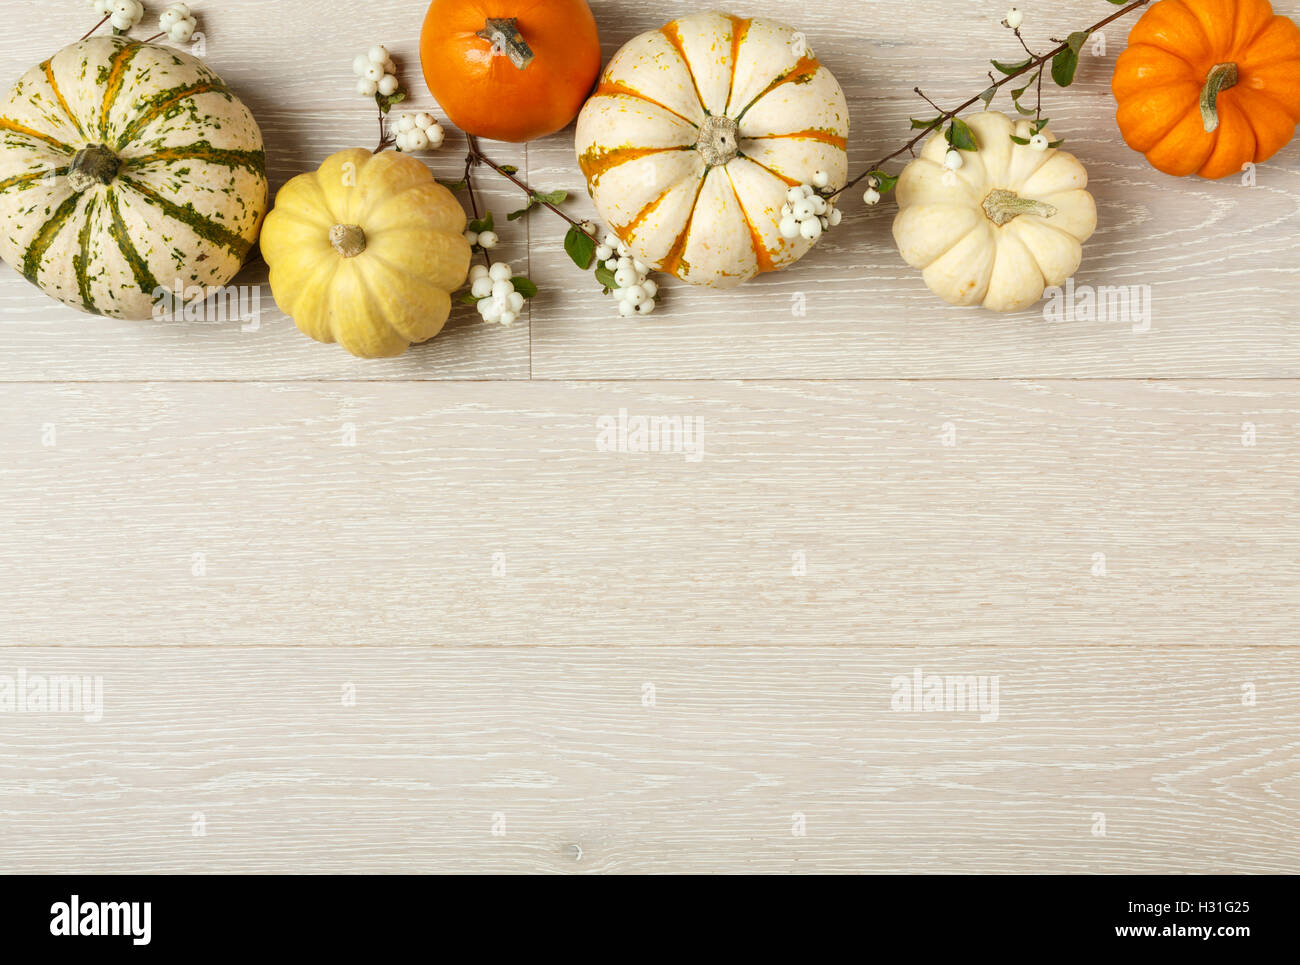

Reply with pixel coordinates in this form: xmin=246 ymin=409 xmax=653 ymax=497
xmin=0 ymin=0 xmax=1300 ymax=873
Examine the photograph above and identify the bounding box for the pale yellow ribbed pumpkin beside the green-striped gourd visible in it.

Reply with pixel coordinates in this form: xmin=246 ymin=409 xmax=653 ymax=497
xmin=261 ymin=148 xmax=471 ymax=359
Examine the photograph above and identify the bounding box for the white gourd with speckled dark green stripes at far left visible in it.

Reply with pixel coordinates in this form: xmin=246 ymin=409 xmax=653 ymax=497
xmin=0 ymin=36 xmax=268 ymax=319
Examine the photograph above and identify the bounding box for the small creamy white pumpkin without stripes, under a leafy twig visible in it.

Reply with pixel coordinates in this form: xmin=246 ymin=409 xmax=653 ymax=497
xmin=893 ymin=111 xmax=1097 ymax=312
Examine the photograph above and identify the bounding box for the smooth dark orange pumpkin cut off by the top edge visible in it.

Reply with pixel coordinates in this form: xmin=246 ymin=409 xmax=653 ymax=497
xmin=420 ymin=0 xmax=601 ymax=140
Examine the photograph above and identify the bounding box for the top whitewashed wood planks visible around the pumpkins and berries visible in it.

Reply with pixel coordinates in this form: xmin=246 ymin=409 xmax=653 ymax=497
xmin=0 ymin=0 xmax=1300 ymax=381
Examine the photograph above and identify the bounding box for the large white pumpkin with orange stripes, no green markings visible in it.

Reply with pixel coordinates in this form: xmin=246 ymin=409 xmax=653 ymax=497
xmin=577 ymin=13 xmax=849 ymax=287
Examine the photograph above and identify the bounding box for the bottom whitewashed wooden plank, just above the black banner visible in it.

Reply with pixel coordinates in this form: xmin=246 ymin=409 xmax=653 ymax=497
xmin=0 ymin=646 xmax=1300 ymax=874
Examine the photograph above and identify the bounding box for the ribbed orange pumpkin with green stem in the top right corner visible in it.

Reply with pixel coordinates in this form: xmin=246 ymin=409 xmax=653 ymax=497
xmin=1110 ymin=0 xmax=1300 ymax=178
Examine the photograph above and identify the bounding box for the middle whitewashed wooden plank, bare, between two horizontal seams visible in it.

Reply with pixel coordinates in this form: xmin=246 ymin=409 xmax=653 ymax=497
xmin=0 ymin=382 xmax=1300 ymax=648
